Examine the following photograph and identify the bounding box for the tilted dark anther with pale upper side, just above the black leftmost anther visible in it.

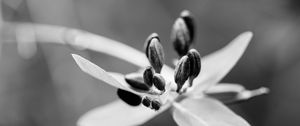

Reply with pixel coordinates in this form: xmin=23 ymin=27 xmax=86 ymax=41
xmin=125 ymin=73 xmax=150 ymax=91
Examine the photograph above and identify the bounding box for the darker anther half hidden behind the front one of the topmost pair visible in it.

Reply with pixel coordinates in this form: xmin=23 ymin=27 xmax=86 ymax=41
xmin=180 ymin=10 xmax=196 ymax=43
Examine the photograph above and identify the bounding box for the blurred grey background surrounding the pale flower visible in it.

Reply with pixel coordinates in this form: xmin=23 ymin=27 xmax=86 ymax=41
xmin=0 ymin=0 xmax=300 ymax=126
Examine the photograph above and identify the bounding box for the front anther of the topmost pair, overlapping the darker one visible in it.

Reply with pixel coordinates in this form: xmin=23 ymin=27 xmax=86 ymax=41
xmin=171 ymin=18 xmax=191 ymax=56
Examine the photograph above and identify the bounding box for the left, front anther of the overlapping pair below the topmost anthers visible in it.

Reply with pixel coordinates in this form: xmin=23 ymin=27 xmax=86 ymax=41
xmin=175 ymin=55 xmax=191 ymax=92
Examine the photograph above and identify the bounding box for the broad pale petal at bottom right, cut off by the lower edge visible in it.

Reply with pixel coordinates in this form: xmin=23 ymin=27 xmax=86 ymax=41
xmin=173 ymin=98 xmax=250 ymax=126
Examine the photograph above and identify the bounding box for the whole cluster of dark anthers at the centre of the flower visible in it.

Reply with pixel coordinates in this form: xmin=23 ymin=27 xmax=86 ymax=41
xmin=118 ymin=11 xmax=201 ymax=110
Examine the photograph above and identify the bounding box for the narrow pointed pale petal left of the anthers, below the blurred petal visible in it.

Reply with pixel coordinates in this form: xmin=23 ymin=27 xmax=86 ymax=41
xmin=72 ymin=54 xmax=127 ymax=90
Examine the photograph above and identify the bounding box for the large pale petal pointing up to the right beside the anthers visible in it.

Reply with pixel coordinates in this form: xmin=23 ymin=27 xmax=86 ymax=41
xmin=192 ymin=32 xmax=253 ymax=93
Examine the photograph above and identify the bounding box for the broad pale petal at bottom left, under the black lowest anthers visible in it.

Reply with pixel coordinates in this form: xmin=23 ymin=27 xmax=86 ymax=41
xmin=78 ymin=100 xmax=170 ymax=126
